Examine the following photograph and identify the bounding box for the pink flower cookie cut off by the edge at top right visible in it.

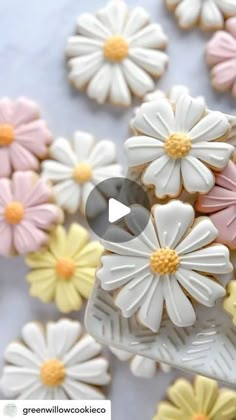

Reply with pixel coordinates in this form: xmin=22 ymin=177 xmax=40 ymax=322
xmin=206 ymin=17 xmax=236 ymax=97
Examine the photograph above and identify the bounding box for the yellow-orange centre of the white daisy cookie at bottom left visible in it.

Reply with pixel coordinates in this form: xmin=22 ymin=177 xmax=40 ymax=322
xmin=40 ymin=359 xmax=66 ymax=387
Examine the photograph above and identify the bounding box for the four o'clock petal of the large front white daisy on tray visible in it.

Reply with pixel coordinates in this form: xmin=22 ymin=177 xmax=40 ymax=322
xmin=175 ymin=268 xmax=226 ymax=307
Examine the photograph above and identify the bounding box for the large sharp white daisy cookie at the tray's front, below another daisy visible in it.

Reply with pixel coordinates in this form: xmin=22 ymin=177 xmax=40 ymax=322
xmin=97 ymin=200 xmax=232 ymax=332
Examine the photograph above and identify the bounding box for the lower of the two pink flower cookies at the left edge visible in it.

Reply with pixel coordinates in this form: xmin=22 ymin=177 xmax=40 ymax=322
xmin=0 ymin=171 xmax=63 ymax=256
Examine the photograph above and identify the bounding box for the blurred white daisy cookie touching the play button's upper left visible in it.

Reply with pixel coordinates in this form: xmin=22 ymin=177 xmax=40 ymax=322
xmin=42 ymin=131 xmax=122 ymax=217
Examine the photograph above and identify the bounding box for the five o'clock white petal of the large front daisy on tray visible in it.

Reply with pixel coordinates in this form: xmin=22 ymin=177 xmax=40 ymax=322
xmin=162 ymin=275 xmax=196 ymax=327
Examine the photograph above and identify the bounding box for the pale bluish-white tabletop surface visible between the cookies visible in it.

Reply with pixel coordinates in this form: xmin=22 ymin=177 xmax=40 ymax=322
xmin=0 ymin=0 xmax=236 ymax=420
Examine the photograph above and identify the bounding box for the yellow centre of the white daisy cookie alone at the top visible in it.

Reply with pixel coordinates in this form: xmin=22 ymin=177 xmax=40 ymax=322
xmin=103 ymin=35 xmax=129 ymax=61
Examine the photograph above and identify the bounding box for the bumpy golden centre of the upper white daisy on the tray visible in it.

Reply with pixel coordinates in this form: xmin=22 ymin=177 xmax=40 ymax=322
xmin=165 ymin=133 xmax=192 ymax=159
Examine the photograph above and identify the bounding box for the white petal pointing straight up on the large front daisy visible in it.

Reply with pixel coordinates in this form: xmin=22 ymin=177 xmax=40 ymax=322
xmin=154 ymin=201 xmax=194 ymax=249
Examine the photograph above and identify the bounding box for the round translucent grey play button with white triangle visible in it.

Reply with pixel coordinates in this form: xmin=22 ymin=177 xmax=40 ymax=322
xmin=86 ymin=178 xmax=150 ymax=242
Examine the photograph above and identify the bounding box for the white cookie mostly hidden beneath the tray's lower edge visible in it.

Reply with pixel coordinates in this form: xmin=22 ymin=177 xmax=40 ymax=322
xmin=110 ymin=347 xmax=171 ymax=379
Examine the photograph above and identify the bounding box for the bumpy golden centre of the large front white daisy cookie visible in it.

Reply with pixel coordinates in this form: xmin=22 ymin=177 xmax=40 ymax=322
xmin=150 ymin=248 xmax=180 ymax=274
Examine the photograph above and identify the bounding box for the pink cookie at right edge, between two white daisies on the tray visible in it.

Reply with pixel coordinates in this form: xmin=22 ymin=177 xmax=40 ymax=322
xmin=196 ymin=161 xmax=236 ymax=248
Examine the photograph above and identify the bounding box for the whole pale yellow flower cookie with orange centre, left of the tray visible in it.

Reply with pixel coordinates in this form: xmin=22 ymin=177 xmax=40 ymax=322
xmin=26 ymin=224 xmax=103 ymax=312
